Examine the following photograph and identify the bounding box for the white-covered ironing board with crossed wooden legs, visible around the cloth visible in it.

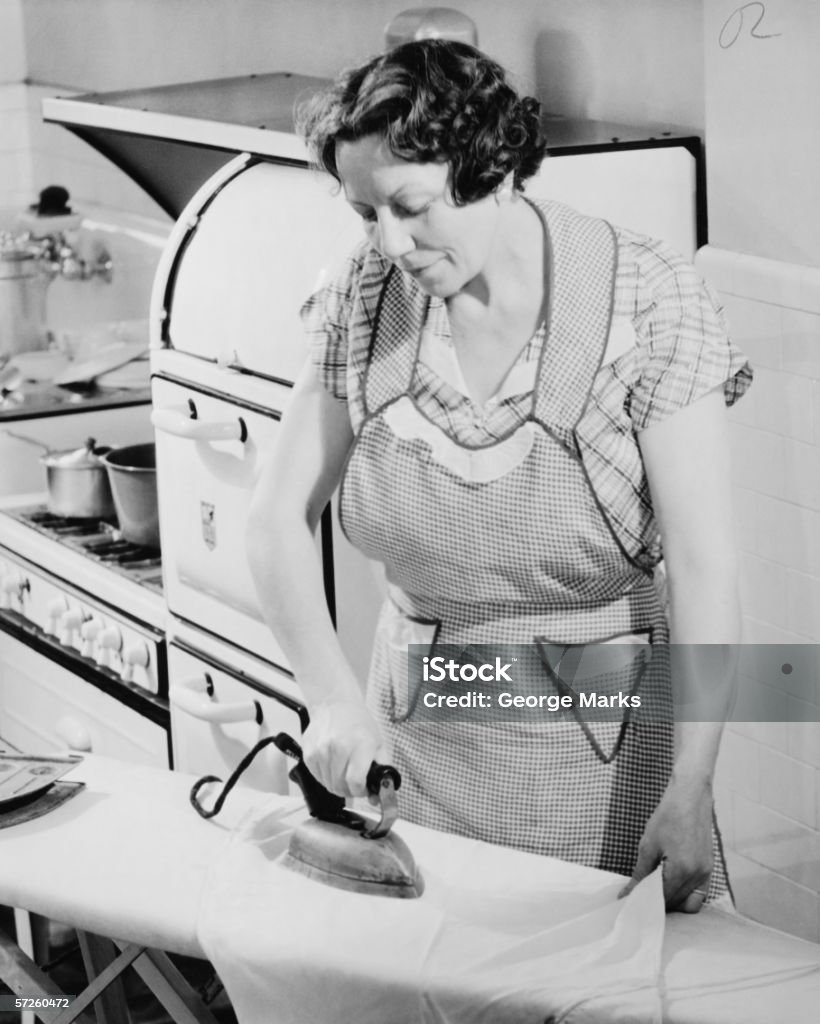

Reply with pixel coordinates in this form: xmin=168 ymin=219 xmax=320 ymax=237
xmin=0 ymin=755 xmax=820 ymax=1024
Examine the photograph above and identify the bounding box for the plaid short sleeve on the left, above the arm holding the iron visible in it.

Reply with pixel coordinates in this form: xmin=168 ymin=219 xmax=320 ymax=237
xmin=300 ymin=244 xmax=369 ymax=401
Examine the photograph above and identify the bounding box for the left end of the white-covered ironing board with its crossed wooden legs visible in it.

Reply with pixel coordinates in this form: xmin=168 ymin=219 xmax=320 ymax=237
xmin=0 ymin=756 xmax=258 ymax=1024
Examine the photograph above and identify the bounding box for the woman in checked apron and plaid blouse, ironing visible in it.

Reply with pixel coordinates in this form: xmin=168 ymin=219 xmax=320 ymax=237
xmin=249 ymin=40 xmax=750 ymax=911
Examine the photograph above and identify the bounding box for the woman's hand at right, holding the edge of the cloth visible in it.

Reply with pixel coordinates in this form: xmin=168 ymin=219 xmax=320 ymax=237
xmin=619 ymin=775 xmax=714 ymax=913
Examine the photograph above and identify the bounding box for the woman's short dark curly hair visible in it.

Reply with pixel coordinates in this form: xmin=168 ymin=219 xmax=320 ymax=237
xmin=297 ymin=39 xmax=547 ymax=205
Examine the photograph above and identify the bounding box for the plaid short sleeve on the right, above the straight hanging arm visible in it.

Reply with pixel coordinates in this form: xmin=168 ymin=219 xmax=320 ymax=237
xmin=629 ymin=246 xmax=752 ymax=430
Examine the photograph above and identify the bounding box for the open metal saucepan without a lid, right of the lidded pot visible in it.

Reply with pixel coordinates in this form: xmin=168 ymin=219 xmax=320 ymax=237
xmin=102 ymin=443 xmax=160 ymax=550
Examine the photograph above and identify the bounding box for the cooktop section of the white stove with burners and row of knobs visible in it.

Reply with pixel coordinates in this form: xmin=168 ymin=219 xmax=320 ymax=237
xmin=0 ymin=495 xmax=171 ymax=767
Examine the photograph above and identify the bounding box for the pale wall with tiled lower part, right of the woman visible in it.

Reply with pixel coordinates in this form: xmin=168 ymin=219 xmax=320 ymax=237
xmin=700 ymin=0 xmax=820 ymax=941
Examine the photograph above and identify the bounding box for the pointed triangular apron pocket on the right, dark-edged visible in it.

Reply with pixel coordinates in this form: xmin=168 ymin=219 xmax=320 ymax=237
xmin=534 ymin=630 xmax=652 ymax=764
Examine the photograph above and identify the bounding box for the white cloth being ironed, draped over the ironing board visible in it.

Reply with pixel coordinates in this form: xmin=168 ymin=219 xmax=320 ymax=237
xmin=200 ymin=803 xmax=664 ymax=1024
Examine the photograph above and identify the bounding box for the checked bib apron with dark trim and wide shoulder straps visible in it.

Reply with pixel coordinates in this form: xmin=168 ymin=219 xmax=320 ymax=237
xmin=340 ymin=197 xmax=726 ymax=897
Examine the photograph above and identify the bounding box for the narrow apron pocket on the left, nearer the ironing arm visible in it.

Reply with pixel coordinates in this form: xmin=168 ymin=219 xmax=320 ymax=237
xmin=380 ymin=599 xmax=441 ymax=723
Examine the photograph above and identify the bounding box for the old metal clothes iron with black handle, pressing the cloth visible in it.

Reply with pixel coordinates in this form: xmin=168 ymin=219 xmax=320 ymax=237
xmin=272 ymin=732 xmax=424 ymax=899
